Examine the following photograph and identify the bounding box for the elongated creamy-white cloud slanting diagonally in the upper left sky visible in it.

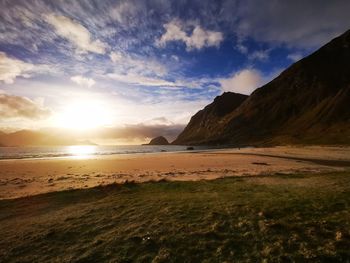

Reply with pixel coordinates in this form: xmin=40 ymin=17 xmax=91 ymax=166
xmin=45 ymin=14 xmax=107 ymax=54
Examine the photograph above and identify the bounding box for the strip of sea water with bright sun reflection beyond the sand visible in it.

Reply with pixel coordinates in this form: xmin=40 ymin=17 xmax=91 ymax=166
xmin=0 ymin=145 xmax=206 ymax=159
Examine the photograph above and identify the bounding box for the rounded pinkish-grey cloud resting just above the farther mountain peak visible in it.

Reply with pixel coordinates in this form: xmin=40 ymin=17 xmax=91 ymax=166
xmin=219 ymin=69 xmax=264 ymax=95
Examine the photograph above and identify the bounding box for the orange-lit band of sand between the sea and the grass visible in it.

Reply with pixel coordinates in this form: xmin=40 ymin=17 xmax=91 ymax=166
xmin=0 ymin=147 xmax=350 ymax=199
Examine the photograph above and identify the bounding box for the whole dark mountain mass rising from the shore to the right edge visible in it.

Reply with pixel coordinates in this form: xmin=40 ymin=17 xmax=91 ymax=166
xmin=174 ymin=30 xmax=350 ymax=145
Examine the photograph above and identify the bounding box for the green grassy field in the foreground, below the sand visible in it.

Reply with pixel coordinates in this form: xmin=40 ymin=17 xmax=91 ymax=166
xmin=0 ymin=172 xmax=350 ymax=262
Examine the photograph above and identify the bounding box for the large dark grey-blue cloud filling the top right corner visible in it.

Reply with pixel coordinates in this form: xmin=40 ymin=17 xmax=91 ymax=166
xmin=231 ymin=0 xmax=350 ymax=48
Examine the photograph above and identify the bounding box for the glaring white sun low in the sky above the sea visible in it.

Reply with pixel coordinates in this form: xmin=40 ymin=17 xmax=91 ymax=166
xmin=55 ymin=100 xmax=112 ymax=130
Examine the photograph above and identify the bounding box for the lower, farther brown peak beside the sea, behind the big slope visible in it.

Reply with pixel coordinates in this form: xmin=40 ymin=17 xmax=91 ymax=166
xmin=173 ymin=92 xmax=248 ymax=145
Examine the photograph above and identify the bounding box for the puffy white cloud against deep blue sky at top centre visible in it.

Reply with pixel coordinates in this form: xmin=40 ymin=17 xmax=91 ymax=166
xmin=156 ymin=20 xmax=224 ymax=50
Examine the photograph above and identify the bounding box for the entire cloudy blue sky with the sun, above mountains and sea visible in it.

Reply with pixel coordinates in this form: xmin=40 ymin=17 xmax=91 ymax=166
xmin=0 ymin=0 xmax=350 ymax=144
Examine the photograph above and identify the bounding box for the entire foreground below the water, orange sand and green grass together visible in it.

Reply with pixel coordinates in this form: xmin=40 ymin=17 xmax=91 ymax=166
xmin=0 ymin=146 xmax=350 ymax=262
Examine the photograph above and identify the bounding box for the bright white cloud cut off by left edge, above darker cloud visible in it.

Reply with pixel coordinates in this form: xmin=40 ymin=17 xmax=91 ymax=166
xmin=0 ymin=52 xmax=34 ymax=84
